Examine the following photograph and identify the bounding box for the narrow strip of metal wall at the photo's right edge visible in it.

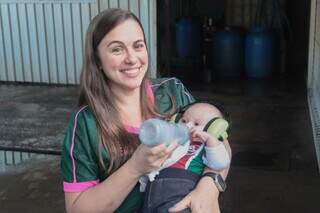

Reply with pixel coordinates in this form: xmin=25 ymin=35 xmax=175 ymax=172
xmin=308 ymin=0 xmax=320 ymax=171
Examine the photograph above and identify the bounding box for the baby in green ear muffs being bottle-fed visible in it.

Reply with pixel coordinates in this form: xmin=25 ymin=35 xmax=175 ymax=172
xmin=140 ymin=102 xmax=230 ymax=213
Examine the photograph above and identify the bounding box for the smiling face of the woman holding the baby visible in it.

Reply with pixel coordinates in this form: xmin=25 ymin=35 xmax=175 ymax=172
xmin=98 ymin=19 xmax=148 ymax=91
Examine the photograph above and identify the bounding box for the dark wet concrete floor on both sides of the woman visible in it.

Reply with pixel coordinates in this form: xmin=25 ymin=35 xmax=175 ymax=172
xmin=0 ymin=77 xmax=320 ymax=213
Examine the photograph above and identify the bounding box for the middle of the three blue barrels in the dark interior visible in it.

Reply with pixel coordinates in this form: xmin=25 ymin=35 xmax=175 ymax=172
xmin=212 ymin=28 xmax=244 ymax=78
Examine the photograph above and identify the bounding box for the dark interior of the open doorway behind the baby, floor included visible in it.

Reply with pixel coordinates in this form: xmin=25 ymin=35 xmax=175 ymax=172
xmin=157 ymin=0 xmax=320 ymax=213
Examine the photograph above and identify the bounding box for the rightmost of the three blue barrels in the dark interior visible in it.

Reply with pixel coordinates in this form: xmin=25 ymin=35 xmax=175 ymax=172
xmin=245 ymin=27 xmax=276 ymax=78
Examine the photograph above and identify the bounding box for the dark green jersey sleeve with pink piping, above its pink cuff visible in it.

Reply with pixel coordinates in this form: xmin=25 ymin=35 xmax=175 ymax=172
xmin=61 ymin=108 xmax=99 ymax=183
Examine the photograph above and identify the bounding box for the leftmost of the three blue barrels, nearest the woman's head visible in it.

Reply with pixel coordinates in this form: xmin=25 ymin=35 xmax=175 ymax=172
xmin=176 ymin=17 xmax=202 ymax=59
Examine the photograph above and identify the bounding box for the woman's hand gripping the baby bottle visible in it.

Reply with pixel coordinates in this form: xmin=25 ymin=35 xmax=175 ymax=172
xmin=128 ymin=141 xmax=178 ymax=176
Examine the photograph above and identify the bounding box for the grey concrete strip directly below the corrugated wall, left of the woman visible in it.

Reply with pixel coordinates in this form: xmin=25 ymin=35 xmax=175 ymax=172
xmin=0 ymin=85 xmax=77 ymax=153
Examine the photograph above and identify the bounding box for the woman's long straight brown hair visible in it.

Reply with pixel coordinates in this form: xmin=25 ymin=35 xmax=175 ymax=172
xmin=79 ymin=9 xmax=168 ymax=174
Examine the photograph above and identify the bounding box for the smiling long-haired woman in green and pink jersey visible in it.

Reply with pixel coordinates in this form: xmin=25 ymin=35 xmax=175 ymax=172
xmin=61 ymin=9 xmax=227 ymax=213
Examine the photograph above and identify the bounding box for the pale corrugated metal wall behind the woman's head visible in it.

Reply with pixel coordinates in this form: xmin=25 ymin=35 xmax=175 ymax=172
xmin=0 ymin=0 xmax=156 ymax=84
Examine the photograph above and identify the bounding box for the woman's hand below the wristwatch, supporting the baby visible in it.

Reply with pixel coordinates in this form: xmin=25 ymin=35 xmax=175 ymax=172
xmin=169 ymin=177 xmax=220 ymax=213
